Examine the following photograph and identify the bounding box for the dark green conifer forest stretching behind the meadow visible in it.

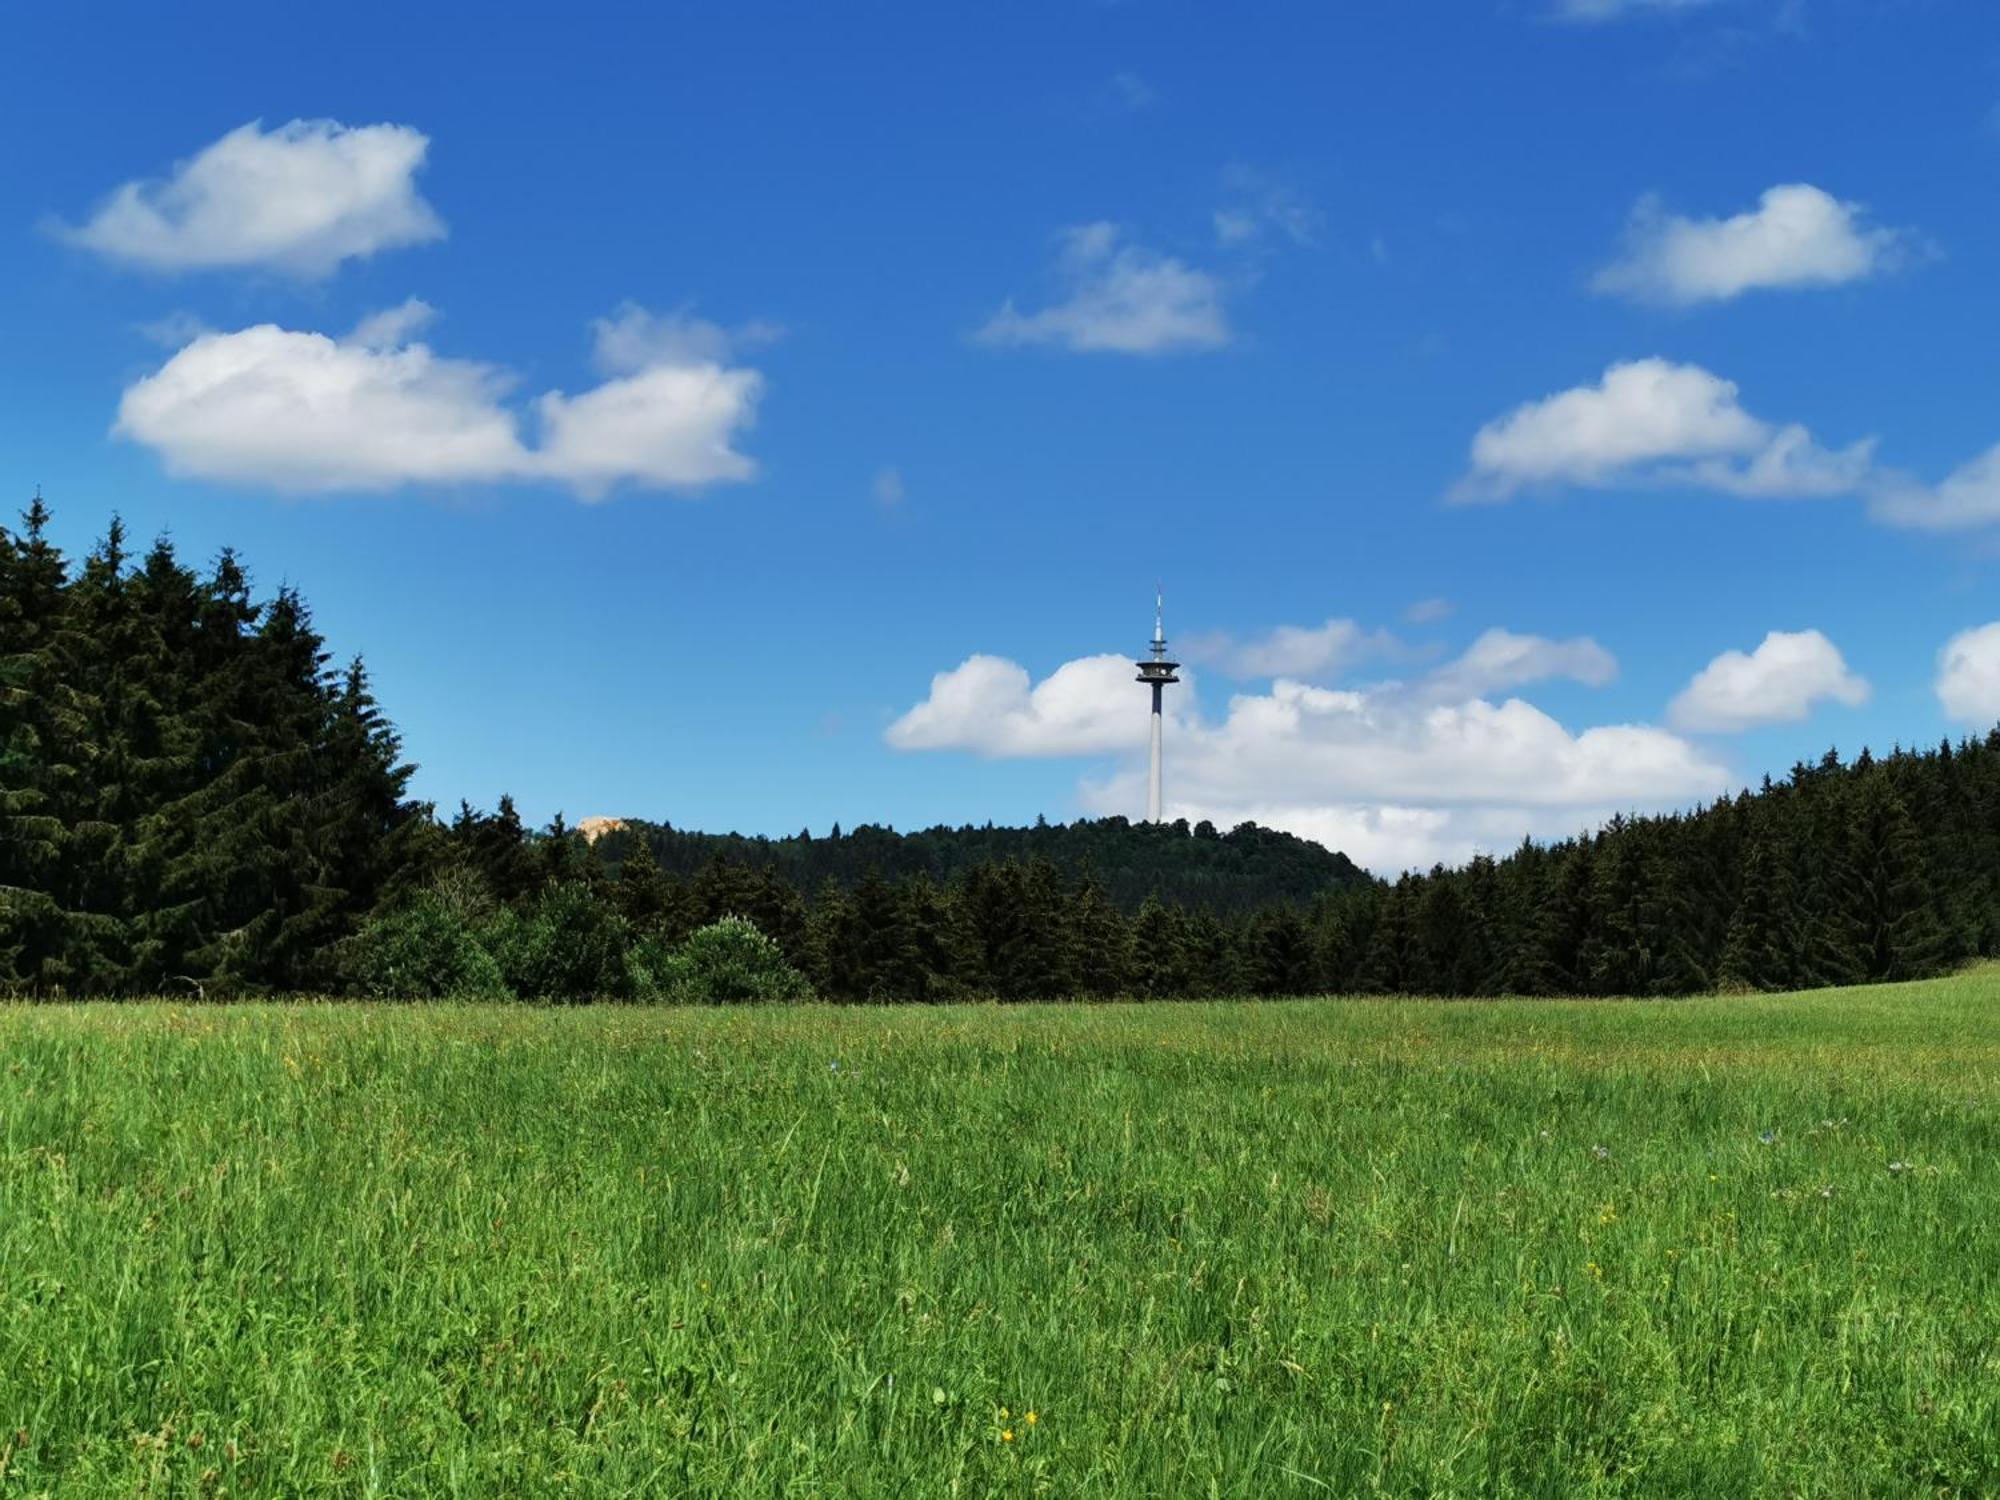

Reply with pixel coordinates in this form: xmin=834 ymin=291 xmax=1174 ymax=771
xmin=0 ymin=500 xmax=2000 ymax=1002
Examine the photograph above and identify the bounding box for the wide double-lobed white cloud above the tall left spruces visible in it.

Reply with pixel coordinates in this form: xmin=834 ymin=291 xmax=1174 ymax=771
xmin=116 ymin=300 xmax=762 ymax=498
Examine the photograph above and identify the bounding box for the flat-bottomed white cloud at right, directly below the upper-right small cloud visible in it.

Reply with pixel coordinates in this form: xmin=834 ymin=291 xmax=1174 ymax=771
xmin=1456 ymin=358 xmax=1874 ymax=500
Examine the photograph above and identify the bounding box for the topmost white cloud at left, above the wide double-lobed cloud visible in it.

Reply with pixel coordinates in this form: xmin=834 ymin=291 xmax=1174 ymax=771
xmin=56 ymin=120 xmax=444 ymax=278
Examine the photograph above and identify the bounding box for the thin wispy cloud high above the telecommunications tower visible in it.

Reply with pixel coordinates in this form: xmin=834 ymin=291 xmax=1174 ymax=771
xmin=976 ymin=222 xmax=1230 ymax=354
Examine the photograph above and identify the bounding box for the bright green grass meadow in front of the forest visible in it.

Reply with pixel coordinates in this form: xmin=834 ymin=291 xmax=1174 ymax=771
xmin=0 ymin=970 xmax=2000 ymax=1498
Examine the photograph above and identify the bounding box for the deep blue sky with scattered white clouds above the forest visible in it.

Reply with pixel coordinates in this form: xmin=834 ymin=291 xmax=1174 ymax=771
xmin=0 ymin=0 xmax=2000 ymax=870
